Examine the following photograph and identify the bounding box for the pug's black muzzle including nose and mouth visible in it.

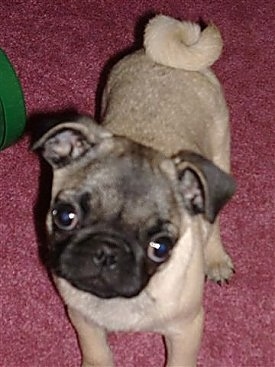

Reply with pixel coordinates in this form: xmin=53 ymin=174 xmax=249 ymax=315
xmin=51 ymin=233 xmax=149 ymax=298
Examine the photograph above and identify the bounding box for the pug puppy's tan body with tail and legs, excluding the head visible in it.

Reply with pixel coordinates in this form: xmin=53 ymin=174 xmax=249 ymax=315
xmin=45 ymin=16 xmax=235 ymax=367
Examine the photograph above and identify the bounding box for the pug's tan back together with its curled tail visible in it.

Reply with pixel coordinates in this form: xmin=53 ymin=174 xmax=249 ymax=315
xmin=102 ymin=16 xmax=228 ymax=169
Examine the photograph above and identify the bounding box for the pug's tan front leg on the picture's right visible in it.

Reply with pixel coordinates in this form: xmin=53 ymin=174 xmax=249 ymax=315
xmin=164 ymin=308 xmax=204 ymax=367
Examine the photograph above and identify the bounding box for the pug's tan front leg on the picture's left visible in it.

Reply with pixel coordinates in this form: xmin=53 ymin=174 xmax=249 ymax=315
xmin=68 ymin=309 xmax=113 ymax=367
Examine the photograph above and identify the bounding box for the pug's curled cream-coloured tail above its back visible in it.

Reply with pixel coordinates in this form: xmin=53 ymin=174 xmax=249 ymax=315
xmin=144 ymin=15 xmax=223 ymax=71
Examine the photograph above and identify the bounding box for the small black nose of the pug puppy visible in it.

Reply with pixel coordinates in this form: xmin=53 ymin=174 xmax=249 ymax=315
xmin=92 ymin=244 xmax=119 ymax=270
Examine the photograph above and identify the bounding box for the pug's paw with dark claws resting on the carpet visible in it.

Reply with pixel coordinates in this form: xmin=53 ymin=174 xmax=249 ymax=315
xmin=206 ymin=253 xmax=235 ymax=285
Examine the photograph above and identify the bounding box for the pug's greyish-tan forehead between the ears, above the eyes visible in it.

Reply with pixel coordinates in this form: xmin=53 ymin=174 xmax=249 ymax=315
xmin=53 ymin=155 xmax=181 ymax=227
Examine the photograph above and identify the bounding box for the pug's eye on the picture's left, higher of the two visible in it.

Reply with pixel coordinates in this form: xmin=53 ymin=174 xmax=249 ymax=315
xmin=52 ymin=203 xmax=78 ymax=231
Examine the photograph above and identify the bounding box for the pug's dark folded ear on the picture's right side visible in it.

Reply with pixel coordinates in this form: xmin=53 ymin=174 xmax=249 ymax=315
xmin=173 ymin=151 xmax=236 ymax=223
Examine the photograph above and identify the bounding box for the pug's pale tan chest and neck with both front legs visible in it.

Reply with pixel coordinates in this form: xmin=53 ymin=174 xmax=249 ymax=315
xmin=55 ymin=217 xmax=206 ymax=367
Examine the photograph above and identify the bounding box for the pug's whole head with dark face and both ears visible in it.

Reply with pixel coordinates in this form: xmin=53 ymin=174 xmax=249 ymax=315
xmin=35 ymin=117 xmax=237 ymax=298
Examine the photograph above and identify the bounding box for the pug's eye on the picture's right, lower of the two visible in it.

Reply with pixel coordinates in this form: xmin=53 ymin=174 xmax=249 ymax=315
xmin=147 ymin=236 xmax=172 ymax=263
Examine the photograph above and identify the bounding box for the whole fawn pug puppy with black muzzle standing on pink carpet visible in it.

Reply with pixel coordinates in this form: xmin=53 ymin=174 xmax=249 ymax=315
xmin=34 ymin=15 xmax=235 ymax=367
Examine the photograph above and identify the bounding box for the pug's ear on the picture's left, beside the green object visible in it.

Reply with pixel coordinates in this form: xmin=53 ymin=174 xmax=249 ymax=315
xmin=33 ymin=116 xmax=112 ymax=169
